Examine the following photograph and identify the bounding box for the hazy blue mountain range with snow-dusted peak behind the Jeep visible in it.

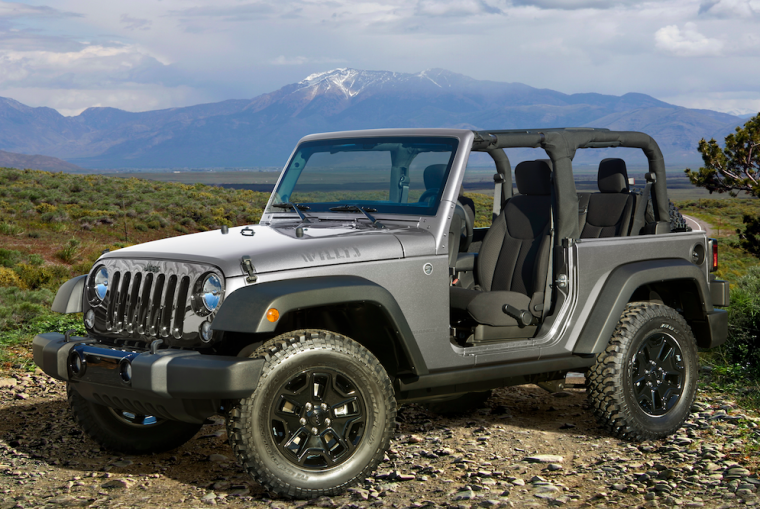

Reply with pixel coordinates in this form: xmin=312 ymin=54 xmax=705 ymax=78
xmin=0 ymin=69 xmax=746 ymax=170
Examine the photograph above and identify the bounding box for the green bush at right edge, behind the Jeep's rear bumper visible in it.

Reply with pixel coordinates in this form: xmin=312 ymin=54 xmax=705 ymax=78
xmin=721 ymin=266 xmax=760 ymax=378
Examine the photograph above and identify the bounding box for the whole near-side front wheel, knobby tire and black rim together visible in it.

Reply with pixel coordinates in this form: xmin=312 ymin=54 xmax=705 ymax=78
xmin=227 ymin=330 xmax=396 ymax=498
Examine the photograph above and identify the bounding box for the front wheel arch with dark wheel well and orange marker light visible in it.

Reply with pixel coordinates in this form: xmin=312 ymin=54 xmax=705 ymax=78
xmin=212 ymin=276 xmax=428 ymax=377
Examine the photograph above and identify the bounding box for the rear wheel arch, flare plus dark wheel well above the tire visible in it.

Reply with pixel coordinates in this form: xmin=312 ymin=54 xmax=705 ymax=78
xmin=573 ymin=258 xmax=725 ymax=355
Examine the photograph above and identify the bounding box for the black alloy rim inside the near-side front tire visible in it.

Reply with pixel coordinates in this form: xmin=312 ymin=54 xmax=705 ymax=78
xmin=269 ymin=367 xmax=366 ymax=470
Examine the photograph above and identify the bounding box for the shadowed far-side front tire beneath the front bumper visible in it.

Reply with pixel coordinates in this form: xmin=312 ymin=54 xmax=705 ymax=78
xmin=66 ymin=384 xmax=202 ymax=455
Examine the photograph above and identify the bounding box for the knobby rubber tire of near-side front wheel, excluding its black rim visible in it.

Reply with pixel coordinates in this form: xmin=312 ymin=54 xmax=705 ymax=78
xmin=226 ymin=330 xmax=396 ymax=498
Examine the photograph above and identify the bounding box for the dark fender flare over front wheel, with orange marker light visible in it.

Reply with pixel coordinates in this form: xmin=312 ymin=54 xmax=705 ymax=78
xmin=211 ymin=276 xmax=428 ymax=375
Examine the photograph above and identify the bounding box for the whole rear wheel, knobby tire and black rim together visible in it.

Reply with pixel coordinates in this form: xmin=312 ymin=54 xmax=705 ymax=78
xmin=586 ymin=302 xmax=698 ymax=440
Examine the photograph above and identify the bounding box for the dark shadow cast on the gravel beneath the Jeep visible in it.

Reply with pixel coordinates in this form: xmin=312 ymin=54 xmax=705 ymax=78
xmin=0 ymin=385 xmax=605 ymax=498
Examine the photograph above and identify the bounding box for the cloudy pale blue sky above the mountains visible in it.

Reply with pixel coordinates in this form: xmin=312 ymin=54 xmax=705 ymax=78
xmin=0 ymin=0 xmax=760 ymax=116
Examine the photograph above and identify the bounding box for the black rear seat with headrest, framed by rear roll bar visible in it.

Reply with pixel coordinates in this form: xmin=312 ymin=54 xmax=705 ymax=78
xmin=578 ymin=159 xmax=636 ymax=239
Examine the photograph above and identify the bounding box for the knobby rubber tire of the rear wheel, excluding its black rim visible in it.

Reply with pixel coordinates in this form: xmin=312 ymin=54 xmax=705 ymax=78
xmin=586 ymin=302 xmax=698 ymax=441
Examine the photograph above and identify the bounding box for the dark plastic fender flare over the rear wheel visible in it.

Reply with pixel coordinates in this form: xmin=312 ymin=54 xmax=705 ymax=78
xmin=573 ymin=258 xmax=728 ymax=355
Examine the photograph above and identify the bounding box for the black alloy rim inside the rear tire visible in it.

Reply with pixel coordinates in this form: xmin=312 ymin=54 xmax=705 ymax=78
xmin=631 ymin=333 xmax=686 ymax=416
